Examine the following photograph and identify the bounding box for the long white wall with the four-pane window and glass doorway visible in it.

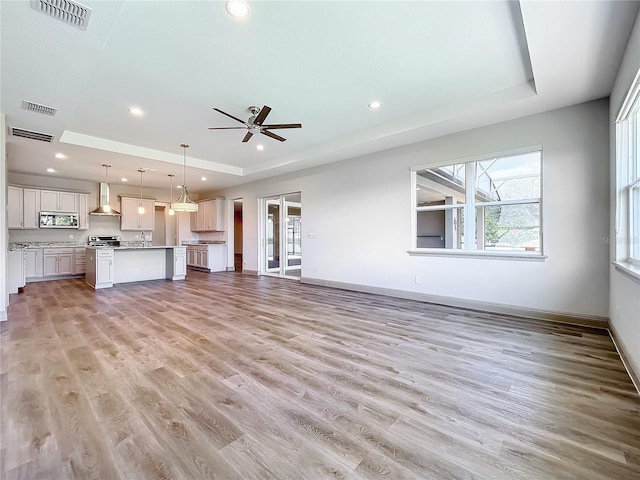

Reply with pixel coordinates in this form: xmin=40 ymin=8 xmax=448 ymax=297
xmin=219 ymin=100 xmax=609 ymax=319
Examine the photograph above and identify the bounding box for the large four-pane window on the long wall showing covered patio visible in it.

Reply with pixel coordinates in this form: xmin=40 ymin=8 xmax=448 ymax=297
xmin=412 ymin=148 xmax=542 ymax=256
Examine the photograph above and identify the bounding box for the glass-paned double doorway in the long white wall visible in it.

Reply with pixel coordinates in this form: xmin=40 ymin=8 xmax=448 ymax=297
xmin=261 ymin=192 xmax=302 ymax=278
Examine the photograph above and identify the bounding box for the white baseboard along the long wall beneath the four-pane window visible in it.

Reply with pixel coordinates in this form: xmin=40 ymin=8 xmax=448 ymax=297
xmin=300 ymin=278 xmax=609 ymax=330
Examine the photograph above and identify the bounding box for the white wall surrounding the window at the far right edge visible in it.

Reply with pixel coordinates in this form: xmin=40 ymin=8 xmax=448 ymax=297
xmin=609 ymin=10 xmax=640 ymax=376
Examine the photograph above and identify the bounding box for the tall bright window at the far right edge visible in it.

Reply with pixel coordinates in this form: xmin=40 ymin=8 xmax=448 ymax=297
xmin=616 ymin=71 xmax=640 ymax=266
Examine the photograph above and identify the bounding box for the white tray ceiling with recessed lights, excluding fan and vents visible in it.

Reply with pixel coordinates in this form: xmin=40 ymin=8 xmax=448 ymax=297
xmin=0 ymin=1 xmax=640 ymax=192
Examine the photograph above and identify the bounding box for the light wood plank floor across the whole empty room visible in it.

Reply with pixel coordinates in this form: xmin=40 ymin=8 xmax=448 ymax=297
xmin=0 ymin=271 xmax=640 ymax=480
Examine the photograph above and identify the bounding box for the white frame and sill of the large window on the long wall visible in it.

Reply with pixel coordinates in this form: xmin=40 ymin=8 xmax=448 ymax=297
xmin=408 ymin=145 xmax=547 ymax=261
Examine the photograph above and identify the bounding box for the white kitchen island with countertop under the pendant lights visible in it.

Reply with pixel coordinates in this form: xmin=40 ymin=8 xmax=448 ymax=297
xmin=85 ymin=245 xmax=187 ymax=290
